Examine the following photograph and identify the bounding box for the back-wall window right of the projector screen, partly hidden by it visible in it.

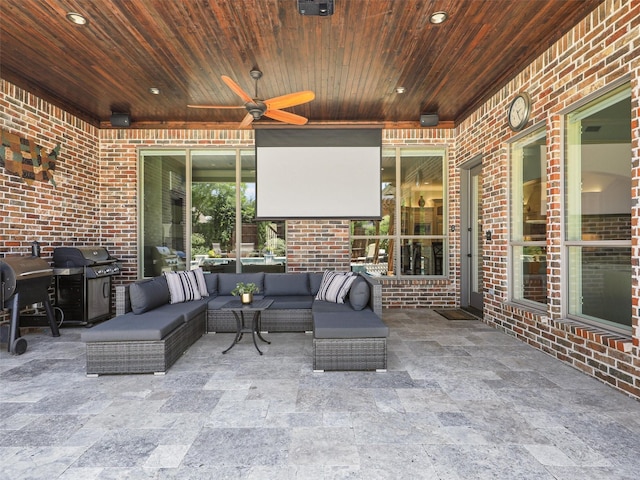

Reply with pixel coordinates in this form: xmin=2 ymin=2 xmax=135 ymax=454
xmin=351 ymin=148 xmax=447 ymax=276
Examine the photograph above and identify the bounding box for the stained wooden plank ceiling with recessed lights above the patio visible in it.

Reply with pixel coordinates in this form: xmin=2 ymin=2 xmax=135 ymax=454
xmin=0 ymin=0 xmax=602 ymax=128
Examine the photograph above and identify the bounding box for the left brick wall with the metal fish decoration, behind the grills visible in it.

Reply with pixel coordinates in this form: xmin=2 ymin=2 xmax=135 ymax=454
xmin=0 ymin=79 xmax=102 ymax=321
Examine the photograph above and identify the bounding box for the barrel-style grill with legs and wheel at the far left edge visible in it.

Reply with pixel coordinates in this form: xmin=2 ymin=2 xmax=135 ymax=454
xmin=0 ymin=256 xmax=60 ymax=355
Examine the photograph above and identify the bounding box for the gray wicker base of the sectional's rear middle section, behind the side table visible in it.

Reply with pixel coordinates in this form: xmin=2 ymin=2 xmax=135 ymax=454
xmin=207 ymin=309 xmax=313 ymax=333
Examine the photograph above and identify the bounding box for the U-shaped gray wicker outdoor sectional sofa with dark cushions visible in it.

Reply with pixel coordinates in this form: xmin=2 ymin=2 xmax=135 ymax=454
xmin=82 ymin=272 xmax=389 ymax=376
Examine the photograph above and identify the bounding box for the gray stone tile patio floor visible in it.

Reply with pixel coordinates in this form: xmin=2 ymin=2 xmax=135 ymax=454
xmin=0 ymin=310 xmax=640 ymax=480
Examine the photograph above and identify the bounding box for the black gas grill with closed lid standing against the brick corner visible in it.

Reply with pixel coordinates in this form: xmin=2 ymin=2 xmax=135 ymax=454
xmin=53 ymin=247 xmax=121 ymax=325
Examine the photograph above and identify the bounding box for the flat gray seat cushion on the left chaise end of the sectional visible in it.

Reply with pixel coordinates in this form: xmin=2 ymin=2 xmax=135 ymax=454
xmin=81 ymin=309 xmax=184 ymax=342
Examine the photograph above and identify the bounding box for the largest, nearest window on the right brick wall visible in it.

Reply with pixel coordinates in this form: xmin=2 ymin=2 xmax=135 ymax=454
xmin=564 ymin=86 xmax=631 ymax=333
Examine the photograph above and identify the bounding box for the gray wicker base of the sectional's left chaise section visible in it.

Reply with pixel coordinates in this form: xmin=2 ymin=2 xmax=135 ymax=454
xmin=87 ymin=312 xmax=206 ymax=376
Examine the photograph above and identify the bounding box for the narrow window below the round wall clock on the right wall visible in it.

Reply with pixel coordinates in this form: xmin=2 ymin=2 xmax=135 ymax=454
xmin=510 ymin=130 xmax=547 ymax=306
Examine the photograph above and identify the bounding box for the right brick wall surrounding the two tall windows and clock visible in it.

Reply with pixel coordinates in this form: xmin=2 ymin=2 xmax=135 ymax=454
xmin=456 ymin=0 xmax=640 ymax=398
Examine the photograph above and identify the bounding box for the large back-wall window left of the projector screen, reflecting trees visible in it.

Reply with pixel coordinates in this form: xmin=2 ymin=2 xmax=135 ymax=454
xmin=140 ymin=149 xmax=286 ymax=277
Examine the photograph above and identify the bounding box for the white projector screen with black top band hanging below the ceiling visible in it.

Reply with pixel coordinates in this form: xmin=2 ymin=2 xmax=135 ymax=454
xmin=255 ymin=128 xmax=382 ymax=220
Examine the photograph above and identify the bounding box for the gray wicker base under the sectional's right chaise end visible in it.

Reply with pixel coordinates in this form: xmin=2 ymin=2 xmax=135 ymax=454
xmin=313 ymin=338 xmax=387 ymax=371
